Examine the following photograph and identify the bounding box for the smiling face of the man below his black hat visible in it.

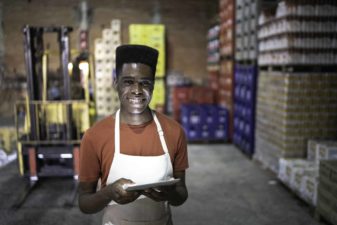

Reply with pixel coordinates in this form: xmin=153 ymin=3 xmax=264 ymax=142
xmin=117 ymin=63 xmax=154 ymax=114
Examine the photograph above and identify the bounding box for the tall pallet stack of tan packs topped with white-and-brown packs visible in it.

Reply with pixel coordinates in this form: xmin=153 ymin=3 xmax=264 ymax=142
xmin=254 ymin=0 xmax=337 ymax=172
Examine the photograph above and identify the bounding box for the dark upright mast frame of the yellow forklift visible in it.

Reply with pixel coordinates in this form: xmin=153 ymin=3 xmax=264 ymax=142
xmin=23 ymin=25 xmax=72 ymax=140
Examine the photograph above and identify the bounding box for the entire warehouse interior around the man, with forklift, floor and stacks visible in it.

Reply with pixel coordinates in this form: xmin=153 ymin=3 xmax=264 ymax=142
xmin=0 ymin=0 xmax=337 ymax=225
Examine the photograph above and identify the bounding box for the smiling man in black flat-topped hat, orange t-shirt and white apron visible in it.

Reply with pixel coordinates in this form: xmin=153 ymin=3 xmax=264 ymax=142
xmin=79 ymin=45 xmax=188 ymax=225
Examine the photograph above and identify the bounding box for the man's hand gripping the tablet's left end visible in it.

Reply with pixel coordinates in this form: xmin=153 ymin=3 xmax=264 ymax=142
xmin=107 ymin=178 xmax=140 ymax=204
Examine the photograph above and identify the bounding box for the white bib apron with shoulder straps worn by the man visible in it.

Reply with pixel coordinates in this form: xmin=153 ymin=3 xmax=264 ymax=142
xmin=103 ymin=110 xmax=173 ymax=225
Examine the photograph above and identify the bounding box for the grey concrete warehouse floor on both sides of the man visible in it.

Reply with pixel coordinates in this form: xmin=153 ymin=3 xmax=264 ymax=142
xmin=0 ymin=144 xmax=320 ymax=225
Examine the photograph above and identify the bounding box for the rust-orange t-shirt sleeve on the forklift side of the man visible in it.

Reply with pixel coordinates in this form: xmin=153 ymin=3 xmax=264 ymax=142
xmin=79 ymin=132 xmax=100 ymax=182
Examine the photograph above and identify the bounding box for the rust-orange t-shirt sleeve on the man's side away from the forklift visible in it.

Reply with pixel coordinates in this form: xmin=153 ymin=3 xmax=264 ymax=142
xmin=173 ymin=127 xmax=189 ymax=171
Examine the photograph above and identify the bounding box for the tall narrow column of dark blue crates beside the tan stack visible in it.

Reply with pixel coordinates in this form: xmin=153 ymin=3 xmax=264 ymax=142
xmin=233 ymin=65 xmax=257 ymax=156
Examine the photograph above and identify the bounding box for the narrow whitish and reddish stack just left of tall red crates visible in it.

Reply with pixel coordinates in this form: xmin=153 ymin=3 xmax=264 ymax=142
xmin=207 ymin=24 xmax=220 ymax=94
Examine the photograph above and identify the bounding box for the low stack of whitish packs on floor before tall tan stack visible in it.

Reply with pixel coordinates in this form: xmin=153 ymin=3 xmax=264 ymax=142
xmin=278 ymin=139 xmax=337 ymax=206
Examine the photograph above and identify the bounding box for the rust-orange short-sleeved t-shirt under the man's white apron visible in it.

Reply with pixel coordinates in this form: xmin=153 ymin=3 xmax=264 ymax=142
xmin=79 ymin=112 xmax=188 ymax=186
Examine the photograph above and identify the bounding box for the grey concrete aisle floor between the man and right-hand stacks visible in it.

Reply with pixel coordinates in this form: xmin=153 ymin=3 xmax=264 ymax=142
xmin=173 ymin=145 xmax=319 ymax=225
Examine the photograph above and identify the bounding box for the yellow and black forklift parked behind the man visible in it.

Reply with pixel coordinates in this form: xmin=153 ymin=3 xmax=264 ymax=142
xmin=14 ymin=25 xmax=93 ymax=208
